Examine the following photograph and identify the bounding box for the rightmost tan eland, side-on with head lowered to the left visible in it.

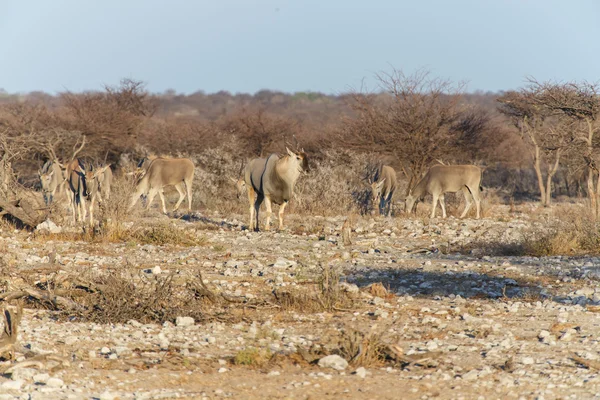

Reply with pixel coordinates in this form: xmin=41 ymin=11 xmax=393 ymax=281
xmin=405 ymin=165 xmax=483 ymax=219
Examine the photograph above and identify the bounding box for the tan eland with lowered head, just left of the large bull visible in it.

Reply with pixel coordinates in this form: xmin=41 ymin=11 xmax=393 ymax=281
xmin=128 ymin=157 xmax=194 ymax=214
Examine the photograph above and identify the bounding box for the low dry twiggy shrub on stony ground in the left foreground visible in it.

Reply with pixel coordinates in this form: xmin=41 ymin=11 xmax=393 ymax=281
xmin=62 ymin=271 xmax=207 ymax=323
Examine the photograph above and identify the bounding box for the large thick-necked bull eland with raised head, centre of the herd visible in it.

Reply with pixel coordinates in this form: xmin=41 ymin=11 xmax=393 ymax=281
xmin=244 ymin=147 xmax=310 ymax=231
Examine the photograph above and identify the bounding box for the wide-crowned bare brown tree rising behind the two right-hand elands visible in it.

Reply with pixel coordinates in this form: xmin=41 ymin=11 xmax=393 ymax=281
xmin=340 ymin=69 xmax=463 ymax=190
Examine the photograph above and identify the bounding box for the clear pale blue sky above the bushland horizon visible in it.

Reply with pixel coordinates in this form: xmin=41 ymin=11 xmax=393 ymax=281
xmin=0 ymin=0 xmax=600 ymax=94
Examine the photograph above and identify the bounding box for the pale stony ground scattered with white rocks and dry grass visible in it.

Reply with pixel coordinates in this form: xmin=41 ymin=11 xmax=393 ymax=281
xmin=0 ymin=187 xmax=600 ymax=399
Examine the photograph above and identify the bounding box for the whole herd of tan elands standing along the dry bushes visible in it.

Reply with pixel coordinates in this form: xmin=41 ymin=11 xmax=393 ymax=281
xmin=39 ymin=138 xmax=483 ymax=231
